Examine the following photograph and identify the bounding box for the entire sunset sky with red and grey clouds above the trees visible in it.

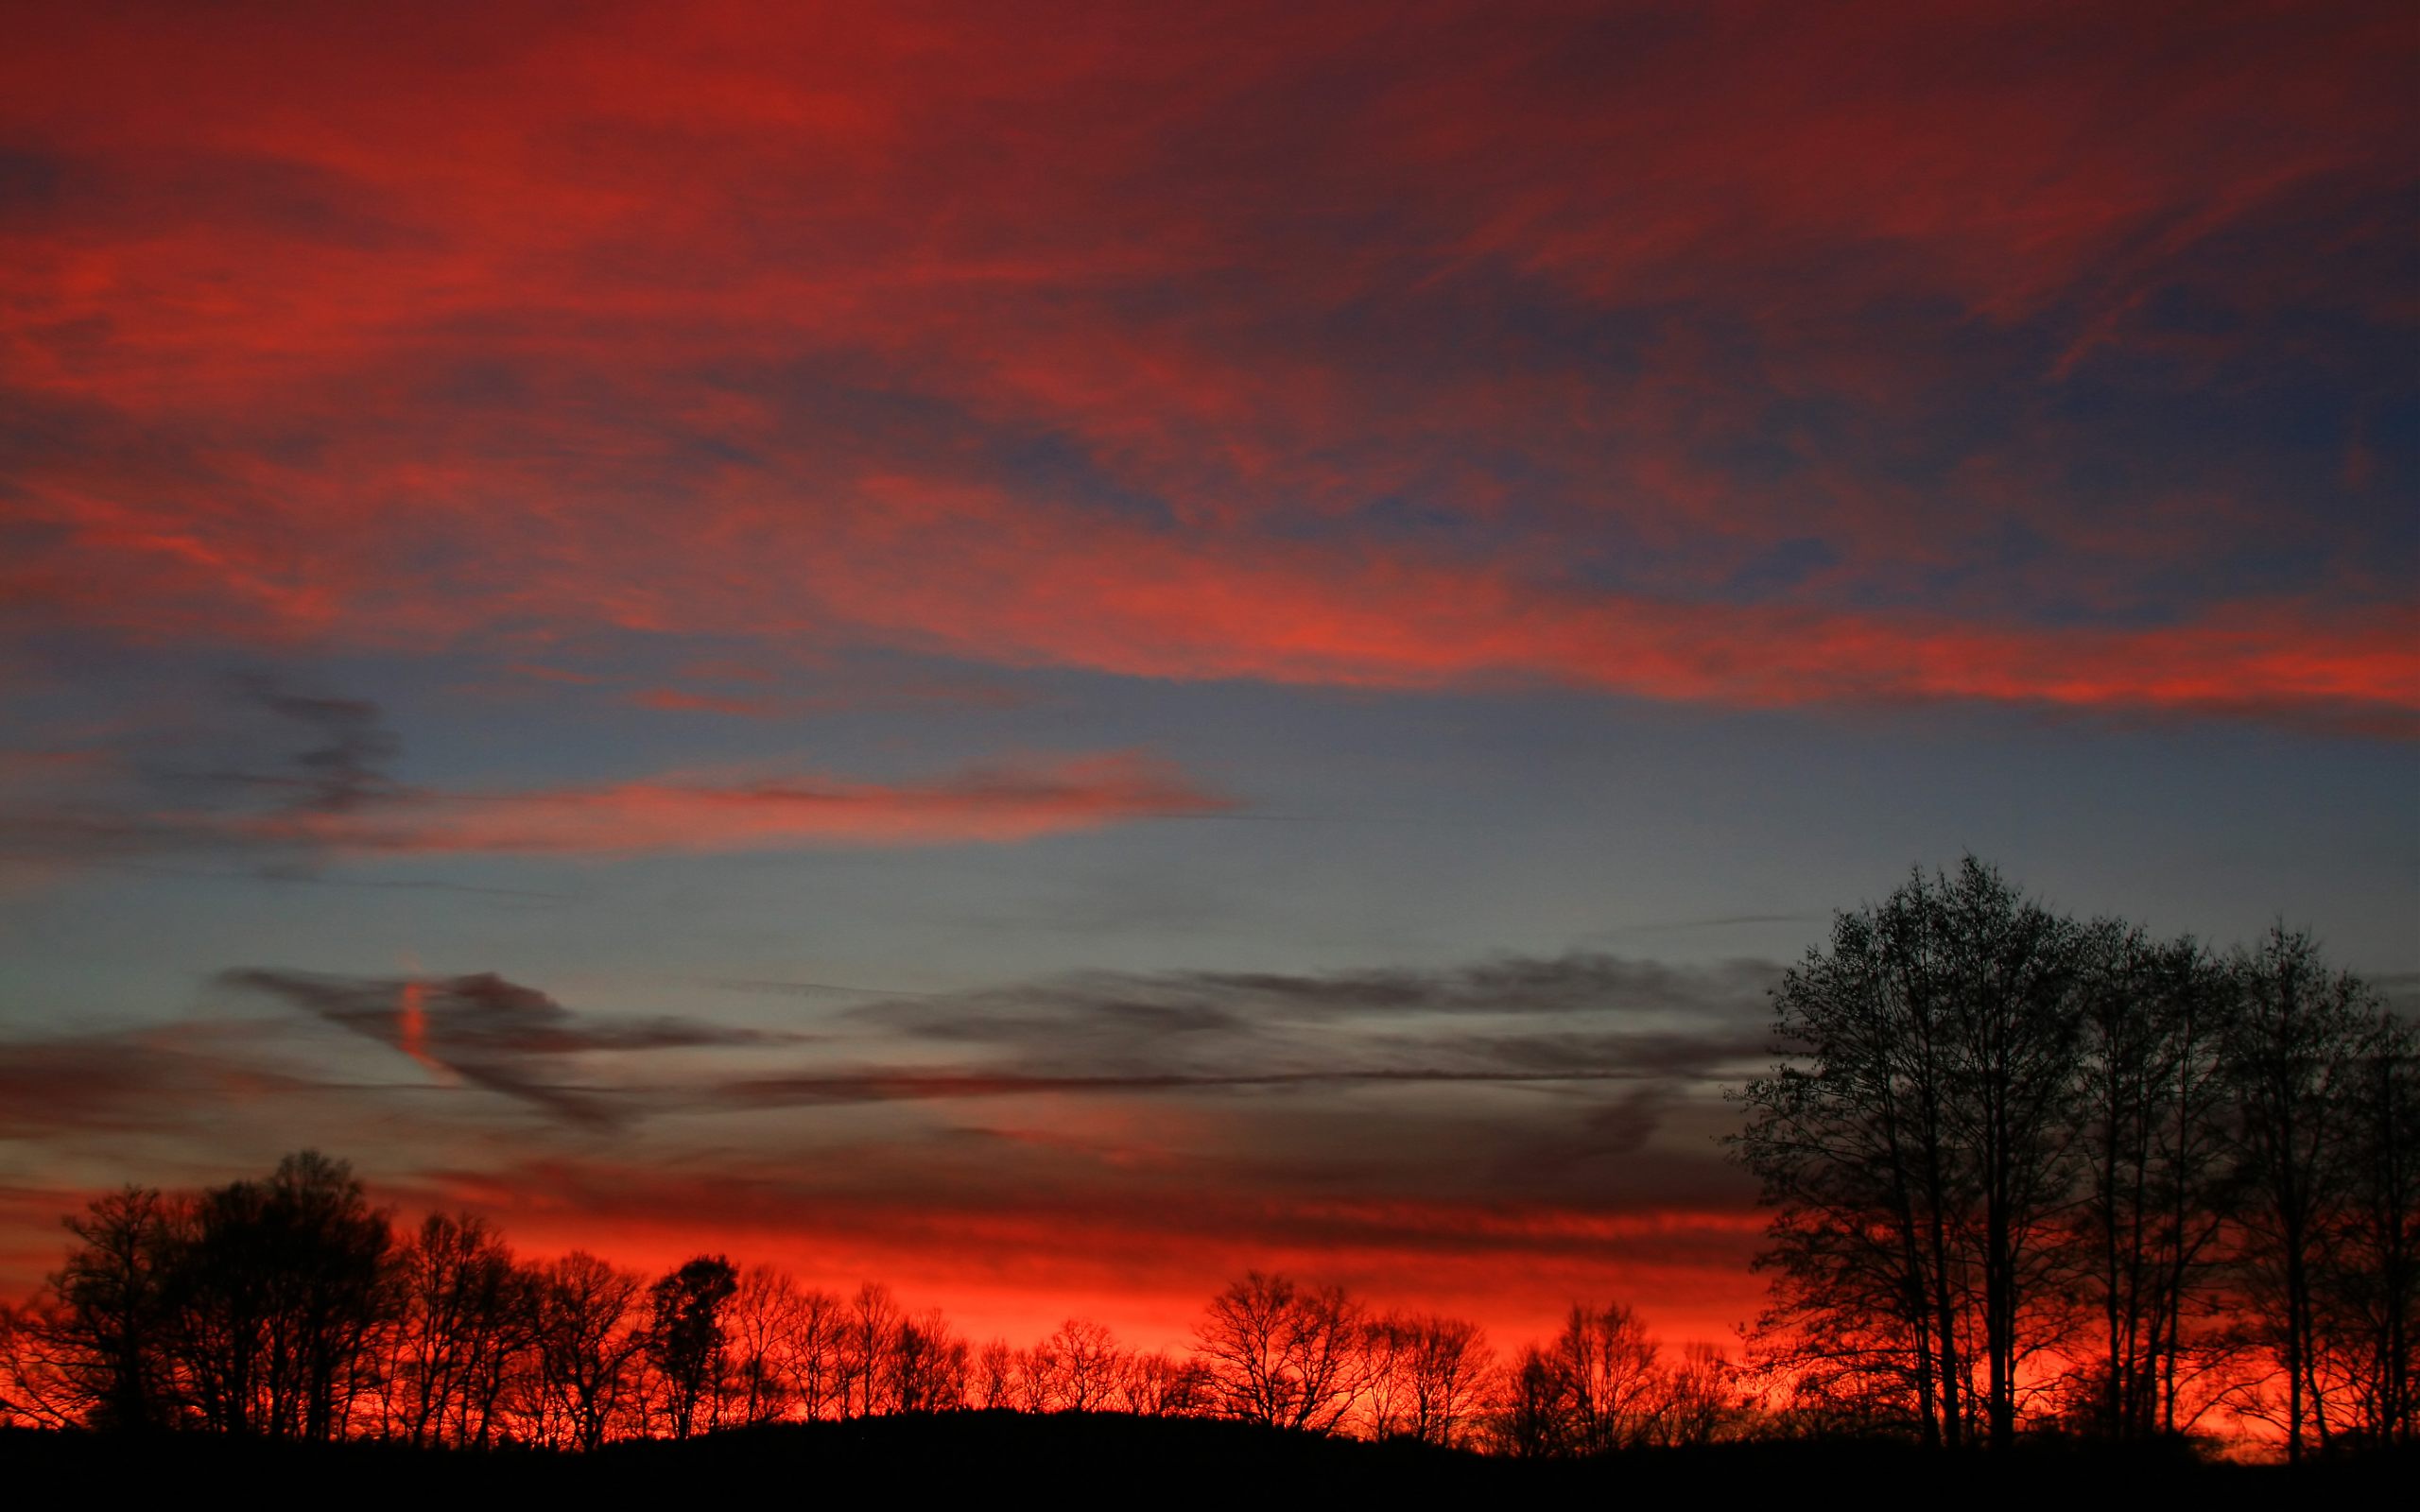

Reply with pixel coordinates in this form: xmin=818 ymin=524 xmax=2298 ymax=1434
xmin=0 ymin=0 xmax=2420 ymax=1345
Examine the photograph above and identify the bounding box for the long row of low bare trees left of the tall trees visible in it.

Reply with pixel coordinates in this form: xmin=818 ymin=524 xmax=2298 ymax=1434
xmin=0 ymin=1152 xmax=1736 ymax=1456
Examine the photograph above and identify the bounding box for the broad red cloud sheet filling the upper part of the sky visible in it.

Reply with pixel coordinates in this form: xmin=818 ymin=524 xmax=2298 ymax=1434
xmin=0 ymin=5 xmax=2420 ymax=729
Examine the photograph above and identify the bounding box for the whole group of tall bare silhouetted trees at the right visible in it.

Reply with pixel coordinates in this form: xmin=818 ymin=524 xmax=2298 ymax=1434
xmin=1736 ymin=859 xmax=2420 ymax=1459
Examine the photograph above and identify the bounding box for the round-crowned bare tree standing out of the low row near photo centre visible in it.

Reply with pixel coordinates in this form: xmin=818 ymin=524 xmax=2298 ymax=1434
xmin=1196 ymin=1270 xmax=1370 ymax=1433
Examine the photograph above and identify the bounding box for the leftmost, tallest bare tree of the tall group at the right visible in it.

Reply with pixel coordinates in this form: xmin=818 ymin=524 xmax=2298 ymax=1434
xmin=1736 ymin=856 xmax=2082 ymax=1444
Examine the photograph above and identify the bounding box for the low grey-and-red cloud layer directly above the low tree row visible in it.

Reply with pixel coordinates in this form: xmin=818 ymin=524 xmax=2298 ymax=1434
xmin=0 ymin=955 xmax=1773 ymax=1328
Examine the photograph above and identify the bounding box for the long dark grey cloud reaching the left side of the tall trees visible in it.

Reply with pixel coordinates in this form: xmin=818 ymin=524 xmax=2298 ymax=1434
xmin=707 ymin=954 xmax=1781 ymax=1171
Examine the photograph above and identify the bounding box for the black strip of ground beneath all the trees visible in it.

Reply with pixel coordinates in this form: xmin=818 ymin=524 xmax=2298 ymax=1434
xmin=0 ymin=1413 xmax=2420 ymax=1512
